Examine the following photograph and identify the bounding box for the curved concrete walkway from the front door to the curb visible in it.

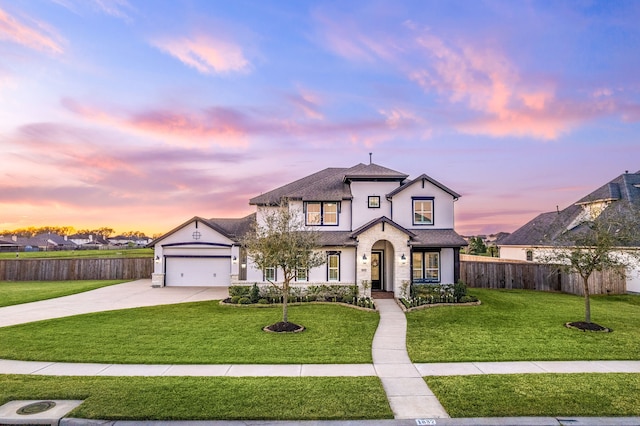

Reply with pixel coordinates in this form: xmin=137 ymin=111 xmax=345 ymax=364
xmin=372 ymin=299 xmax=449 ymax=419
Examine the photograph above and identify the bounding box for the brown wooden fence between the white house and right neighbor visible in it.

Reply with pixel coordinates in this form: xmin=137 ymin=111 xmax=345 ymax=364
xmin=460 ymin=261 xmax=627 ymax=296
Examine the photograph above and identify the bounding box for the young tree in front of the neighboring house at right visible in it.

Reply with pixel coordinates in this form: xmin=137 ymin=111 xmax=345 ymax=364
xmin=536 ymin=201 xmax=640 ymax=323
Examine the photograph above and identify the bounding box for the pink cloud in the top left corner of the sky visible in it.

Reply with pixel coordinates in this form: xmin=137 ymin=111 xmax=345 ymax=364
xmin=0 ymin=9 xmax=64 ymax=54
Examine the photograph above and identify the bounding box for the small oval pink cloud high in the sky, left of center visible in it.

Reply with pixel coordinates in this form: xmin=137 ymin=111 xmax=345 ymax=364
xmin=151 ymin=34 xmax=251 ymax=74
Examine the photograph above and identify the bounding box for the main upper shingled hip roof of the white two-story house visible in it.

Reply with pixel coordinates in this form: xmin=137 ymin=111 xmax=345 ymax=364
xmin=249 ymin=163 xmax=407 ymax=205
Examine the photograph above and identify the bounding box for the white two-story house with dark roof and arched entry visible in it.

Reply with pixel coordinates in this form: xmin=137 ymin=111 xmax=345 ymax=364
xmin=152 ymin=164 xmax=466 ymax=296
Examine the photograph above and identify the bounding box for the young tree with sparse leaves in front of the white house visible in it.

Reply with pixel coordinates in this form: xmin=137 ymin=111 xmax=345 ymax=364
xmin=242 ymin=200 xmax=325 ymax=323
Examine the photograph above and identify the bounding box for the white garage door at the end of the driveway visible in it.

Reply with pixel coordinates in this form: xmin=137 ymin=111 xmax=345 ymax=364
xmin=165 ymin=257 xmax=231 ymax=287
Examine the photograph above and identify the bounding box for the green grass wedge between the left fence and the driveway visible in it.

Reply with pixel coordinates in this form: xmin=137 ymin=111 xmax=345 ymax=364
xmin=0 ymin=280 xmax=125 ymax=307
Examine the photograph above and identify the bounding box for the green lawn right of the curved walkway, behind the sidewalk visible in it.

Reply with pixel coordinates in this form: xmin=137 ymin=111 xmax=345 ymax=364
xmin=407 ymin=289 xmax=640 ymax=362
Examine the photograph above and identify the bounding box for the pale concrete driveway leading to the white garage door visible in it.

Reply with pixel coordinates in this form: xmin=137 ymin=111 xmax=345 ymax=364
xmin=0 ymin=279 xmax=229 ymax=327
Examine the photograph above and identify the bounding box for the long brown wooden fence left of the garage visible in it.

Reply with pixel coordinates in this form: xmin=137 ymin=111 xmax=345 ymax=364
xmin=0 ymin=258 xmax=153 ymax=281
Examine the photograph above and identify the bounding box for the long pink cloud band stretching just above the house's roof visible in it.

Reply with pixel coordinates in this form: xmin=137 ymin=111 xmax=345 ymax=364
xmin=61 ymin=94 xmax=428 ymax=149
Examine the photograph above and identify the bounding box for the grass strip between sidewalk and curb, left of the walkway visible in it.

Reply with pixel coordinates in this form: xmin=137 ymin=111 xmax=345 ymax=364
xmin=0 ymin=375 xmax=393 ymax=420
